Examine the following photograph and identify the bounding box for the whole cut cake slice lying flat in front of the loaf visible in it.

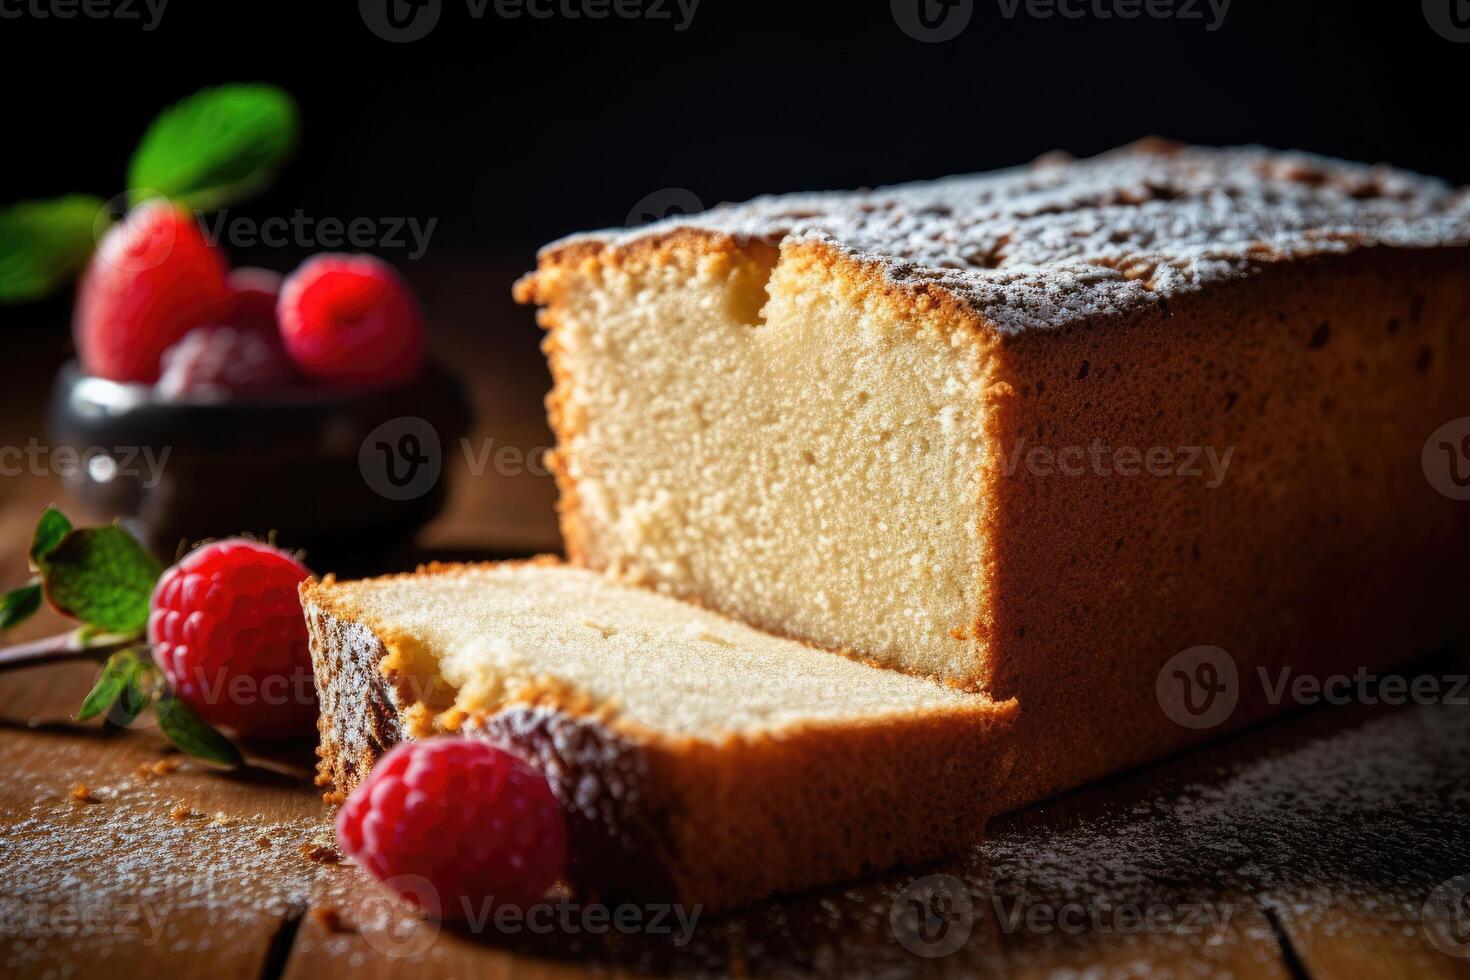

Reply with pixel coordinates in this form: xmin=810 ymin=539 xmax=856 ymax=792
xmin=301 ymin=561 xmax=1016 ymax=911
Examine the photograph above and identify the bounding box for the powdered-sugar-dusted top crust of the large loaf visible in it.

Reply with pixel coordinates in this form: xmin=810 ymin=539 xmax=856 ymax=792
xmin=542 ymin=140 xmax=1470 ymax=331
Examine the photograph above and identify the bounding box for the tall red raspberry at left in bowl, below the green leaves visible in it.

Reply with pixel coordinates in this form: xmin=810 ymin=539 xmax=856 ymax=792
xmin=72 ymin=201 xmax=232 ymax=383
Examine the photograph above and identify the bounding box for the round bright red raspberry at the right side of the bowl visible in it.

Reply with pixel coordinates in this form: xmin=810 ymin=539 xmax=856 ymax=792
xmin=276 ymin=254 xmax=423 ymax=385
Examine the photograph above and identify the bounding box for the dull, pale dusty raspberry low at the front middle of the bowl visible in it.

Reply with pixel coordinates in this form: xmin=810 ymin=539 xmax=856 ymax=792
xmin=154 ymin=326 xmax=295 ymax=401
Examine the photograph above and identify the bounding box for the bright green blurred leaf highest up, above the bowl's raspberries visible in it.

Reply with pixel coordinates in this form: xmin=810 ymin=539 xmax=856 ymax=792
xmin=128 ymin=85 xmax=300 ymax=210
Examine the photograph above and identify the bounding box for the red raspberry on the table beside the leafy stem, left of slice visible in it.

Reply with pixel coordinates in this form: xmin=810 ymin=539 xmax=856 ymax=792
xmin=148 ymin=538 xmax=316 ymax=738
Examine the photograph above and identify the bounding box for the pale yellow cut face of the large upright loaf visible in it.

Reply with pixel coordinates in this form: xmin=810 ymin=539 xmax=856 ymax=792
xmin=520 ymin=232 xmax=991 ymax=689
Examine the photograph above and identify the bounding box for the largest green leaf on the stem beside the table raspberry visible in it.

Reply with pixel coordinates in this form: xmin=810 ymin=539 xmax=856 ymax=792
xmin=41 ymin=525 xmax=163 ymax=636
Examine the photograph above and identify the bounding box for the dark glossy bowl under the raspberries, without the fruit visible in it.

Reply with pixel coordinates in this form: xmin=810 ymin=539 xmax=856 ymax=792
xmin=50 ymin=364 xmax=470 ymax=569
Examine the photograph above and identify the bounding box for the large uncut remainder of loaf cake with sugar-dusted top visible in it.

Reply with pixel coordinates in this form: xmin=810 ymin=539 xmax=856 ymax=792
xmin=516 ymin=140 xmax=1470 ymax=804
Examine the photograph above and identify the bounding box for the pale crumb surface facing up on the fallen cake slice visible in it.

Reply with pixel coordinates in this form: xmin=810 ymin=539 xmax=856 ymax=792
xmin=301 ymin=563 xmax=994 ymax=741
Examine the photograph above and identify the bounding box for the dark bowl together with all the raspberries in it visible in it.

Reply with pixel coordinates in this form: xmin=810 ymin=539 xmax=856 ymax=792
xmin=50 ymin=211 xmax=470 ymax=566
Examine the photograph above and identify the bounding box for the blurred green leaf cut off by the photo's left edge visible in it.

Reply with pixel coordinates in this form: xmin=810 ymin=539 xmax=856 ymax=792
xmin=0 ymin=194 xmax=106 ymax=303
